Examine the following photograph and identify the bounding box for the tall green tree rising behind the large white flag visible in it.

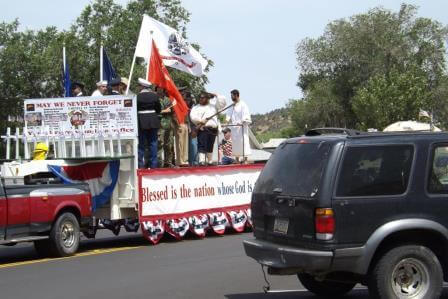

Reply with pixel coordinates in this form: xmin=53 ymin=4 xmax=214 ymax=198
xmin=66 ymin=0 xmax=212 ymax=94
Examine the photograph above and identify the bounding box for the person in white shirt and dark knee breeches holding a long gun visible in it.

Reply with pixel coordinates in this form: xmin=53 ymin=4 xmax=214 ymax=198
xmin=190 ymin=92 xmax=226 ymax=165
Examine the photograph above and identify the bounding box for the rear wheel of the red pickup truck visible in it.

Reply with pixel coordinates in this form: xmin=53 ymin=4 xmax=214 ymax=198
xmin=50 ymin=213 xmax=80 ymax=257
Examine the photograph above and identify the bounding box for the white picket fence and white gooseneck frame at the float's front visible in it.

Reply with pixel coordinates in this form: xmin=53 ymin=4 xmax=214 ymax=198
xmin=0 ymin=126 xmax=138 ymax=219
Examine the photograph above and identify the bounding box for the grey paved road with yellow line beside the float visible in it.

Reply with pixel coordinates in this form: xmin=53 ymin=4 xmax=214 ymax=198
xmin=0 ymin=233 xmax=448 ymax=299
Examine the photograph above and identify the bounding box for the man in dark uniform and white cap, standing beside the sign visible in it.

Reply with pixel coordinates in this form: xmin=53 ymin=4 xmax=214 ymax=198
xmin=137 ymin=78 xmax=161 ymax=168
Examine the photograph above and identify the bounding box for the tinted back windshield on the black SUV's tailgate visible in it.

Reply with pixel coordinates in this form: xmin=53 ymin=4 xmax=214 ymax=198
xmin=254 ymin=142 xmax=331 ymax=197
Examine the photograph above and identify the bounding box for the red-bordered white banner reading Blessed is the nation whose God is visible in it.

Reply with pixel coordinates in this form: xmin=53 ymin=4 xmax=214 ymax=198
xmin=138 ymin=164 xmax=263 ymax=221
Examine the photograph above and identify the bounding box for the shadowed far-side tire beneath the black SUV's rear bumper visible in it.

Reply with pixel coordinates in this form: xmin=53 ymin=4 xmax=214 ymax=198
xmin=297 ymin=273 xmax=356 ymax=298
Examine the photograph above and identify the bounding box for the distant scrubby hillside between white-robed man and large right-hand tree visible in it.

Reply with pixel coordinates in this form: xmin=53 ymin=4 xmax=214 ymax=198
xmin=251 ymin=108 xmax=291 ymax=142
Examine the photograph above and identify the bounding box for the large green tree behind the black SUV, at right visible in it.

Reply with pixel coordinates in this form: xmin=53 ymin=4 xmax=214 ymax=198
xmin=293 ymin=4 xmax=448 ymax=132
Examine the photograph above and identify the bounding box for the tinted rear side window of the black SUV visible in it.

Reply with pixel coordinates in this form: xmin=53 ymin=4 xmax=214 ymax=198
xmin=336 ymin=145 xmax=414 ymax=196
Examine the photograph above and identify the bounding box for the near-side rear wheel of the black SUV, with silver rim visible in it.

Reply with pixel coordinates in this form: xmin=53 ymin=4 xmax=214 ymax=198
xmin=368 ymin=245 xmax=443 ymax=299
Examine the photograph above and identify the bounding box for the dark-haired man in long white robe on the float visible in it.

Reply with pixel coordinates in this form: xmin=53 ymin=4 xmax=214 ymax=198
xmin=226 ymin=89 xmax=252 ymax=162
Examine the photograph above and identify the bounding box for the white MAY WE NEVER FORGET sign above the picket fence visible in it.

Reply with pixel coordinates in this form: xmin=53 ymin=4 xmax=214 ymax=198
xmin=24 ymin=96 xmax=138 ymax=138
